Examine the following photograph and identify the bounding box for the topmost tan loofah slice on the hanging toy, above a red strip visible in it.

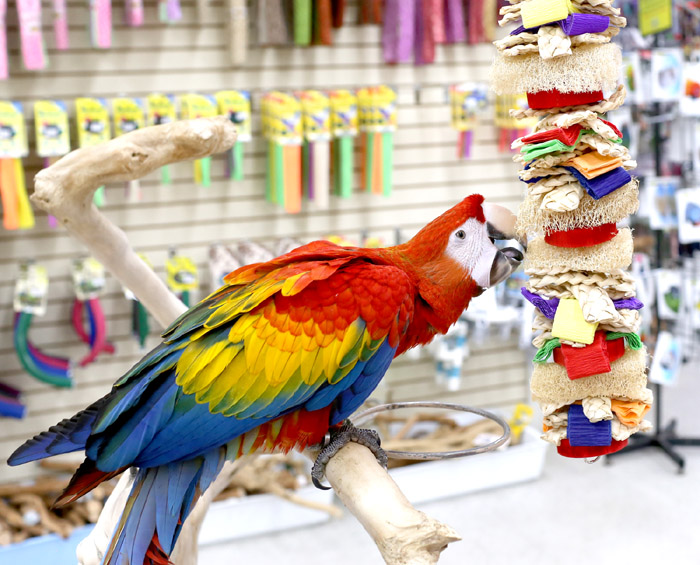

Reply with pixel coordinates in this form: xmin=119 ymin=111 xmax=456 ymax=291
xmin=491 ymin=43 xmax=622 ymax=94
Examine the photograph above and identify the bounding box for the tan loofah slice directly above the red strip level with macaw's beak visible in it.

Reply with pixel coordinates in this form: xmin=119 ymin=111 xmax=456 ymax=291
xmin=515 ymin=175 xmax=639 ymax=236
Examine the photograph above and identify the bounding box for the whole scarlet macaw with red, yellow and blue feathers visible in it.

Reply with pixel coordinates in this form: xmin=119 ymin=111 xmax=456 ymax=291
xmin=9 ymin=195 xmax=523 ymax=565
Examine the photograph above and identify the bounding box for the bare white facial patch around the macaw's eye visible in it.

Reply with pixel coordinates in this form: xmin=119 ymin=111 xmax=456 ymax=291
xmin=445 ymin=218 xmax=498 ymax=287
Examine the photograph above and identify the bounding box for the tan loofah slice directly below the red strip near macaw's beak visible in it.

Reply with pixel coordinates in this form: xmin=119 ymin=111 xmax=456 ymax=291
xmin=524 ymin=228 xmax=633 ymax=273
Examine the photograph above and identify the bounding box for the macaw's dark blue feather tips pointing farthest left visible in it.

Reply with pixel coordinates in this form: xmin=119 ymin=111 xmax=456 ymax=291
xmin=7 ymin=396 xmax=108 ymax=466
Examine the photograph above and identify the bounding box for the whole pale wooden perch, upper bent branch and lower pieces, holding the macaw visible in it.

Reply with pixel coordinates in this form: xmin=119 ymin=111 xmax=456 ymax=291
xmin=32 ymin=116 xmax=459 ymax=565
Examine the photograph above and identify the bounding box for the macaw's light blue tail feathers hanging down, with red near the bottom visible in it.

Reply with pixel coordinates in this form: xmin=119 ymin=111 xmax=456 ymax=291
xmin=102 ymin=449 xmax=225 ymax=565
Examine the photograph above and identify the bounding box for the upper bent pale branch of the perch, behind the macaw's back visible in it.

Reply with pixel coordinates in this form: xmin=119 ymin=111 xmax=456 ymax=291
xmin=32 ymin=116 xmax=236 ymax=327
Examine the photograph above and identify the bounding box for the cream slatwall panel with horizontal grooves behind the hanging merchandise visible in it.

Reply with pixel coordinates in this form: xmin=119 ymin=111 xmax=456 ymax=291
xmin=0 ymin=0 xmax=527 ymax=481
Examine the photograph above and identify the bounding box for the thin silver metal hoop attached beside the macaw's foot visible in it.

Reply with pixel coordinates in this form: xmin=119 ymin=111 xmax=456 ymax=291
xmin=353 ymin=402 xmax=510 ymax=461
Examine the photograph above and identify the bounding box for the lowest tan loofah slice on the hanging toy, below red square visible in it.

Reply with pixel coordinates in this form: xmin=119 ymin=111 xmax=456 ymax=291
xmin=530 ymin=349 xmax=651 ymax=406
